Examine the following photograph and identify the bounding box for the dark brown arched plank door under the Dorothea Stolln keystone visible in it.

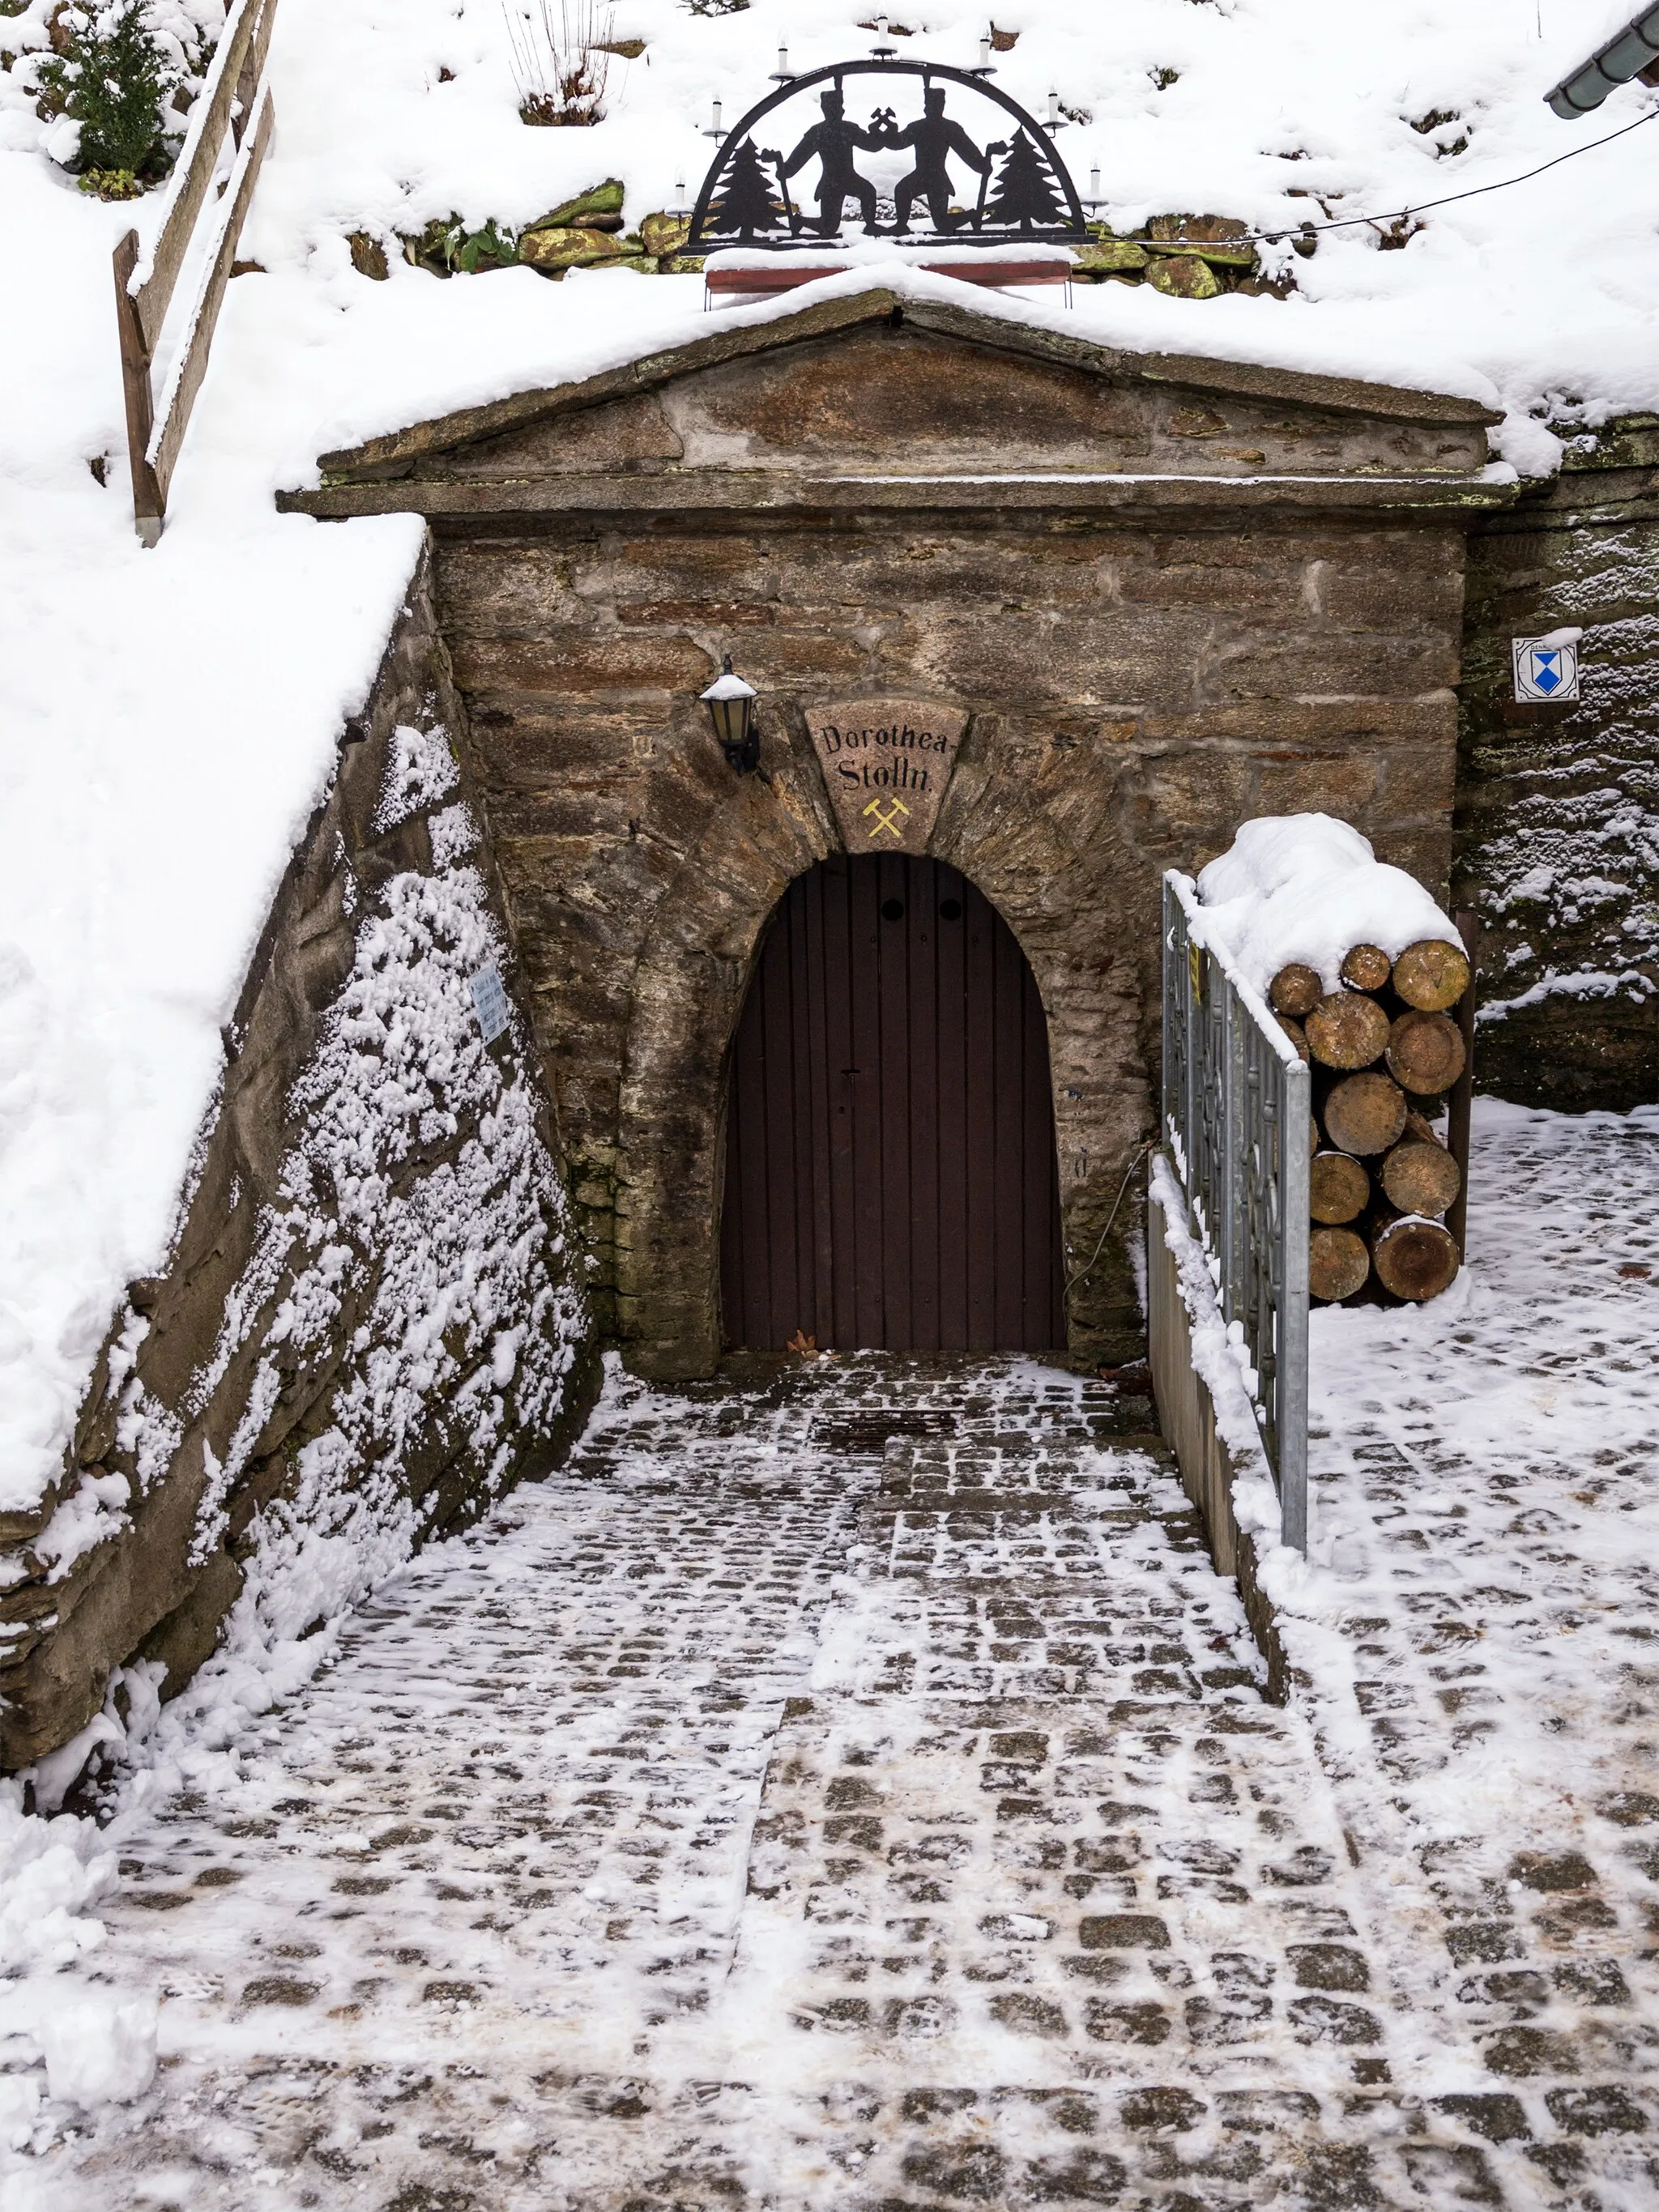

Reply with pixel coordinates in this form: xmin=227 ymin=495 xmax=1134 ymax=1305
xmin=721 ymin=854 xmax=1066 ymax=1352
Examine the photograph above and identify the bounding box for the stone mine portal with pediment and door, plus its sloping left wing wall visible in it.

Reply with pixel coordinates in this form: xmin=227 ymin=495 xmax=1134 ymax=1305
xmin=0 ymin=279 xmax=1516 ymax=1767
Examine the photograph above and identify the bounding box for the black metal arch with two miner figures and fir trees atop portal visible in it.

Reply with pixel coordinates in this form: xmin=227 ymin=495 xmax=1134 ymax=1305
xmin=684 ymin=60 xmax=1088 ymax=254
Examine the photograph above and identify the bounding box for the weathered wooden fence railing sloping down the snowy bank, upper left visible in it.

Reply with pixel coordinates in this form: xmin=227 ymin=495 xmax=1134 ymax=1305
xmin=113 ymin=0 xmax=276 ymax=547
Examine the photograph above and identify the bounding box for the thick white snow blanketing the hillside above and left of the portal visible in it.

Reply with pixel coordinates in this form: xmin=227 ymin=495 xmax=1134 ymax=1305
xmin=0 ymin=0 xmax=1659 ymax=1507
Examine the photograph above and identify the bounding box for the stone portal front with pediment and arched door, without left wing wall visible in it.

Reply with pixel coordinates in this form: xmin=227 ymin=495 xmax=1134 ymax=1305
xmin=288 ymin=290 xmax=1511 ymax=1376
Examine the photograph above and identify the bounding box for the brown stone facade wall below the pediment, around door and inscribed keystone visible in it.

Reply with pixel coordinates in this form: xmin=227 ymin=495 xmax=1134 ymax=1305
xmin=438 ymin=506 xmax=1462 ymax=1374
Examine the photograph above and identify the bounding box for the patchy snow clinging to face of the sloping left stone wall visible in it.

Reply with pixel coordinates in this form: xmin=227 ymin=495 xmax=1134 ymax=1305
xmin=176 ymin=827 xmax=584 ymax=1637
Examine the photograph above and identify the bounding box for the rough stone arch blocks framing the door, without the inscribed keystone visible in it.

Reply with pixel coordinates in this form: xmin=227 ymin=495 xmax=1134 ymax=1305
xmin=610 ymin=710 xmax=1157 ymax=1378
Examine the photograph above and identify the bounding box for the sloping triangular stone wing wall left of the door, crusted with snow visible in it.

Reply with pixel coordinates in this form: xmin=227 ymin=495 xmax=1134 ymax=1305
xmin=0 ymin=569 xmax=597 ymax=1767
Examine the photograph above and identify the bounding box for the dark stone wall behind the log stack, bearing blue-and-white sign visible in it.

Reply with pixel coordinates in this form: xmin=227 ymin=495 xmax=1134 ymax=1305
xmin=1453 ymin=418 xmax=1659 ymax=1110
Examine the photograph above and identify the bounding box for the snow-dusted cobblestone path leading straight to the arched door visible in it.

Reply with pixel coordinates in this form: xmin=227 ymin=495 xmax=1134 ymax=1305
xmin=24 ymin=1318 xmax=1655 ymax=2212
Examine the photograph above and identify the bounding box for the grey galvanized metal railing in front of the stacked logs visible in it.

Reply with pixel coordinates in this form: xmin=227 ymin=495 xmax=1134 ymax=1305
xmin=1163 ymin=869 xmax=1310 ymax=1550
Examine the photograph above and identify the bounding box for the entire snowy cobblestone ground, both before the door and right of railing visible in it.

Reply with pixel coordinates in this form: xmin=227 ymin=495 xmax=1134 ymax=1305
xmin=0 ymin=1104 xmax=1659 ymax=2212
